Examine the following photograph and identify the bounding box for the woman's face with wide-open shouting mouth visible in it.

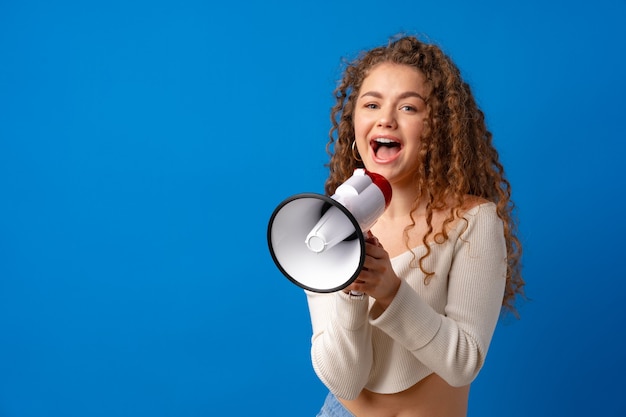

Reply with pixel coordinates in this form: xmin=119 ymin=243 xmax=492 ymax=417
xmin=353 ymin=63 xmax=426 ymax=186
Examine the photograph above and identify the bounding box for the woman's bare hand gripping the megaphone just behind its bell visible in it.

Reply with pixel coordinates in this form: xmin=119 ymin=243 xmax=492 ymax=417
xmin=345 ymin=232 xmax=400 ymax=310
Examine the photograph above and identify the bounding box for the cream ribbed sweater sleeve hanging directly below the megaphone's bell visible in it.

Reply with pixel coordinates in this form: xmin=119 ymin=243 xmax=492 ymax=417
xmin=306 ymin=291 xmax=373 ymax=400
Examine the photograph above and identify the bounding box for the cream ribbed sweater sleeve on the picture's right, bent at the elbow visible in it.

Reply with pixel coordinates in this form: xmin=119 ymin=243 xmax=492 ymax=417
xmin=369 ymin=204 xmax=506 ymax=386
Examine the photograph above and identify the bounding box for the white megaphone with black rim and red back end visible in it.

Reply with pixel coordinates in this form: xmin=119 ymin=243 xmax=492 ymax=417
xmin=267 ymin=168 xmax=391 ymax=293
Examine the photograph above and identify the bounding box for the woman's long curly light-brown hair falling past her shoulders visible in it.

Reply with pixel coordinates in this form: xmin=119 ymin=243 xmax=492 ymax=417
xmin=325 ymin=36 xmax=524 ymax=317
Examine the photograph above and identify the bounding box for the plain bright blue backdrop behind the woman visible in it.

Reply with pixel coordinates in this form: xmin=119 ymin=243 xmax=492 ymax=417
xmin=0 ymin=0 xmax=626 ymax=417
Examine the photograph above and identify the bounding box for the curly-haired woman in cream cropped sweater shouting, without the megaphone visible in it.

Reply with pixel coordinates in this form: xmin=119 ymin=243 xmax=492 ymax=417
xmin=307 ymin=37 xmax=524 ymax=417
